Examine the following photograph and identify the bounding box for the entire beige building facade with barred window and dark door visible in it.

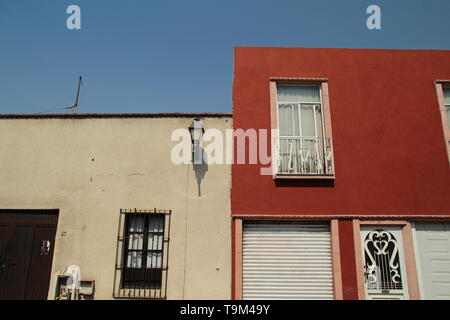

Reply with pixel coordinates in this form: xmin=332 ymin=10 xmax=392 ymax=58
xmin=0 ymin=114 xmax=232 ymax=299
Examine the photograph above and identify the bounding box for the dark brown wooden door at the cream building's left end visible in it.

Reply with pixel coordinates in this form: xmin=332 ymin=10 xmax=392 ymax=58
xmin=0 ymin=210 xmax=58 ymax=300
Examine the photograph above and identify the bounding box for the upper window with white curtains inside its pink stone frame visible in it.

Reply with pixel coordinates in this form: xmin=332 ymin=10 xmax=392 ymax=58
xmin=277 ymin=85 xmax=330 ymax=175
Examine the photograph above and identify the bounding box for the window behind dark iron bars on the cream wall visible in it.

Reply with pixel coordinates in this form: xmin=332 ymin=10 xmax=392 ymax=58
xmin=114 ymin=209 xmax=170 ymax=299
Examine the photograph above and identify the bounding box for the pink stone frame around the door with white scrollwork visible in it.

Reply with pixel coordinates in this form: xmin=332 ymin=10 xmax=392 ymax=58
xmin=353 ymin=219 xmax=420 ymax=300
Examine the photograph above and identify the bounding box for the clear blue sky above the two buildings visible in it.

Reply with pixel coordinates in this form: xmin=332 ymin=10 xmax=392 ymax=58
xmin=0 ymin=0 xmax=450 ymax=113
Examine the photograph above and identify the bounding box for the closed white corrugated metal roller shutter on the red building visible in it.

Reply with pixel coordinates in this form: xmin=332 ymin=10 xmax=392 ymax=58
xmin=243 ymin=222 xmax=333 ymax=300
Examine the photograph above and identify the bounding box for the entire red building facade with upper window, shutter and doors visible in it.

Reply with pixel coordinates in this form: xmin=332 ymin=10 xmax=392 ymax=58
xmin=231 ymin=48 xmax=450 ymax=299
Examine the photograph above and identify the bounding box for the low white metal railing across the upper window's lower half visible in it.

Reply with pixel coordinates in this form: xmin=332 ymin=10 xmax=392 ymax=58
xmin=276 ymin=136 xmax=334 ymax=176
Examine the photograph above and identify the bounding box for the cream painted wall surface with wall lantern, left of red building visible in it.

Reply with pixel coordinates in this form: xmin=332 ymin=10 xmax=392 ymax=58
xmin=0 ymin=117 xmax=232 ymax=299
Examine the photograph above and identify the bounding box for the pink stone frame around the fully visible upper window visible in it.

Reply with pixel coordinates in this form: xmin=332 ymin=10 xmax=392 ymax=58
xmin=269 ymin=78 xmax=335 ymax=180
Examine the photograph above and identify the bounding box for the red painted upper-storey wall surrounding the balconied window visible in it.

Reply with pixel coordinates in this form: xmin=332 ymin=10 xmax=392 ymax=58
xmin=231 ymin=48 xmax=450 ymax=215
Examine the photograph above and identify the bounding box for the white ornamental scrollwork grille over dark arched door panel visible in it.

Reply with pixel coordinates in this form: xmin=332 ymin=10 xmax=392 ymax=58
xmin=364 ymin=229 xmax=403 ymax=290
